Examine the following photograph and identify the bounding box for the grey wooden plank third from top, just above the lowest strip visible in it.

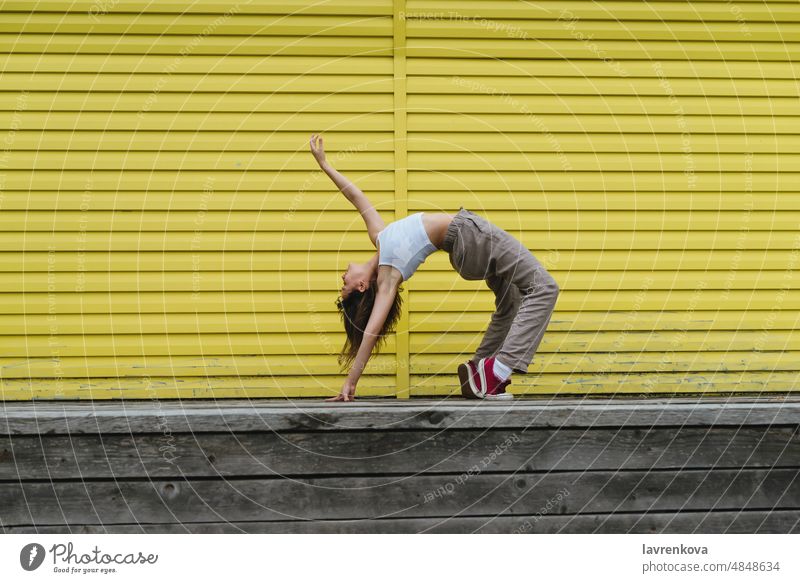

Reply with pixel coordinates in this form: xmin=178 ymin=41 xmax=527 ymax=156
xmin=0 ymin=468 xmax=800 ymax=526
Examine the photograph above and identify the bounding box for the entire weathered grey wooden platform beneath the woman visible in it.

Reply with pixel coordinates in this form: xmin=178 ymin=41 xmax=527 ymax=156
xmin=0 ymin=394 xmax=800 ymax=533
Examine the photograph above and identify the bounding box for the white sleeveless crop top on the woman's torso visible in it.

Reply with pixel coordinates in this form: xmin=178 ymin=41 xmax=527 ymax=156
xmin=378 ymin=213 xmax=437 ymax=281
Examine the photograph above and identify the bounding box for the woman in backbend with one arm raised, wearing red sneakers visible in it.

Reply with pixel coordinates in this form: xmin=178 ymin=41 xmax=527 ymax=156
xmin=311 ymin=134 xmax=559 ymax=401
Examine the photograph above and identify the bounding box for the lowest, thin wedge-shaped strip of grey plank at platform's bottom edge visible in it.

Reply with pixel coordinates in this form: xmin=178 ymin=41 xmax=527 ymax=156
xmin=0 ymin=510 xmax=800 ymax=534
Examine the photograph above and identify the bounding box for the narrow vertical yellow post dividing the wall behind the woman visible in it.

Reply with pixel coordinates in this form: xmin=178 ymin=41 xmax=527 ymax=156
xmin=392 ymin=0 xmax=410 ymax=399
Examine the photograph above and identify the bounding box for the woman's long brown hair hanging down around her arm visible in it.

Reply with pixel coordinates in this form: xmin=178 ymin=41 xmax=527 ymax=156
xmin=336 ymin=279 xmax=403 ymax=372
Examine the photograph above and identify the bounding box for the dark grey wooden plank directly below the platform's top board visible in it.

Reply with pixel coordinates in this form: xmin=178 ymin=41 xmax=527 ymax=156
xmin=0 ymin=425 xmax=800 ymax=480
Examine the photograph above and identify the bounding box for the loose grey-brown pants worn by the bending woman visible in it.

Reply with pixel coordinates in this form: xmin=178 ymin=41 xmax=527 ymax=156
xmin=442 ymin=207 xmax=559 ymax=373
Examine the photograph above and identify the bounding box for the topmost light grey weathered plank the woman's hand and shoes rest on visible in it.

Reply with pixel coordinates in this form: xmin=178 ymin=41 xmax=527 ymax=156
xmin=0 ymin=395 xmax=800 ymax=435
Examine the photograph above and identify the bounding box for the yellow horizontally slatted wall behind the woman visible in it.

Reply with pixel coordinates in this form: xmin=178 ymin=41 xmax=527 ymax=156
xmin=0 ymin=0 xmax=800 ymax=399
